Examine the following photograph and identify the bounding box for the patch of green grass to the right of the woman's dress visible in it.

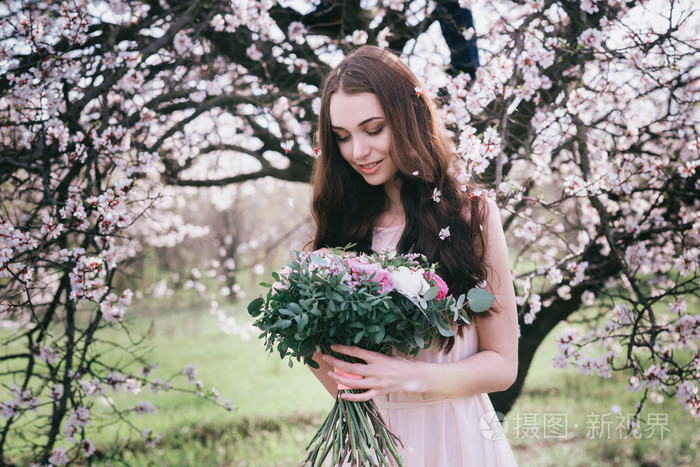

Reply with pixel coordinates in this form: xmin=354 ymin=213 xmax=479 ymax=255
xmin=507 ymin=328 xmax=700 ymax=466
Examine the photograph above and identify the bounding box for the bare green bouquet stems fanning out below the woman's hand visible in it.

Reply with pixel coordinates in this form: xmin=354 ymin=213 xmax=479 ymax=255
xmin=301 ymin=390 xmax=403 ymax=467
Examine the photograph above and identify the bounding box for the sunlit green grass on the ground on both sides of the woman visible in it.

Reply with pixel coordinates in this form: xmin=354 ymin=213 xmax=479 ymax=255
xmin=2 ymin=298 xmax=700 ymax=467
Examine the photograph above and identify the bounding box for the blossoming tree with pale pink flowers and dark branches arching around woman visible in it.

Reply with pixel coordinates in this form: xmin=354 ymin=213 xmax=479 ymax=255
xmin=0 ymin=0 xmax=700 ymax=465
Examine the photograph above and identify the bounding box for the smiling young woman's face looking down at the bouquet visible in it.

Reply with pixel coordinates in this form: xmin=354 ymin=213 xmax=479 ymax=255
xmin=330 ymin=91 xmax=397 ymax=186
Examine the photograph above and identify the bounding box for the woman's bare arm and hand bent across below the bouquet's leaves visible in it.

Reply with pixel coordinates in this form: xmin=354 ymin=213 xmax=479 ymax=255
xmin=319 ymin=197 xmax=518 ymax=400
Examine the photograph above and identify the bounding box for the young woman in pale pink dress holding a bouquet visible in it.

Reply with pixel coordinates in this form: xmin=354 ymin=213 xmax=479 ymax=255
xmin=312 ymin=46 xmax=518 ymax=467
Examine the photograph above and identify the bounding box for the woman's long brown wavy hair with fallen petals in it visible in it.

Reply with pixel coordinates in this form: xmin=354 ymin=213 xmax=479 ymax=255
xmin=311 ymin=46 xmax=486 ymax=349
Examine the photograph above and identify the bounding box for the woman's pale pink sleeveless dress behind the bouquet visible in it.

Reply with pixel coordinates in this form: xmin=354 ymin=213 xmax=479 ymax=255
xmin=372 ymin=225 xmax=517 ymax=467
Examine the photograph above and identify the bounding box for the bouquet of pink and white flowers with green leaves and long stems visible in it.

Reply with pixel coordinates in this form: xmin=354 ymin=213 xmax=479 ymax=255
xmin=248 ymin=247 xmax=494 ymax=466
